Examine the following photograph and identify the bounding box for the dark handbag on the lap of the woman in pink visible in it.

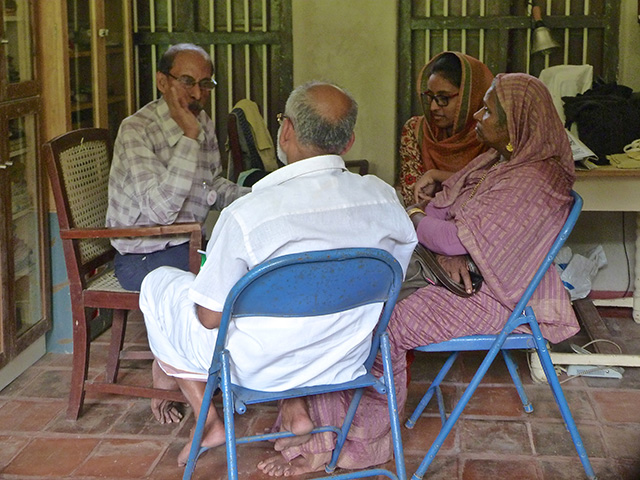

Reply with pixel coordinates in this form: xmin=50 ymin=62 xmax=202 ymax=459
xmin=398 ymin=243 xmax=483 ymax=301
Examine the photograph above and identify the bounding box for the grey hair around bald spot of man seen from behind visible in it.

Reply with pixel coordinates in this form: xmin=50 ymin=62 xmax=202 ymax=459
xmin=285 ymin=81 xmax=358 ymax=155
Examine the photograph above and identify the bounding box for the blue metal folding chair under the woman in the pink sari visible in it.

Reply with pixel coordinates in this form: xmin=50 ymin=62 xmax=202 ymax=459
xmin=405 ymin=192 xmax=596 ymax=480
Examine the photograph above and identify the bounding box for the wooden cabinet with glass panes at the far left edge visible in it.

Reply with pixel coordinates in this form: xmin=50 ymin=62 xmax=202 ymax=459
xmin=0 ymin=0 xmax=50 ymax=374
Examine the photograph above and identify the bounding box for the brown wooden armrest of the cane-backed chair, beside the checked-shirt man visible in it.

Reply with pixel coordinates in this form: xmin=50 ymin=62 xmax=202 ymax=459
xmin=60 ymin=222 xmax=202 ymax=273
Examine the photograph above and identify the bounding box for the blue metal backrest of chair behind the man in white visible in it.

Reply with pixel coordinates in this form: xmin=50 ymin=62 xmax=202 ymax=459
xmin=212 ymin=248 xmax=403 ymax=370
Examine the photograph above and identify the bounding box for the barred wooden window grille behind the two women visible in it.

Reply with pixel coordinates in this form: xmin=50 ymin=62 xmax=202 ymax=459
xmin=397 ymin=0 xmax=620 ymax=176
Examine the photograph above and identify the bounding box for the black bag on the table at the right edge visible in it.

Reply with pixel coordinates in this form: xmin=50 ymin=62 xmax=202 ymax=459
xmin=562 ymin=81 xmax=640 ymax=164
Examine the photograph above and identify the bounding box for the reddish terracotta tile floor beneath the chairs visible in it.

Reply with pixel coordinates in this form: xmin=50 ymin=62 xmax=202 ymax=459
xmin=0 ymin=309 xmax=640 ymax=480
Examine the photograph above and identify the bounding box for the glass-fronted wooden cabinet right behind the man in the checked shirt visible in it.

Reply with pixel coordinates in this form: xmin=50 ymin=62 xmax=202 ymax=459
xmin=67 ymin=0 xmax=132 ymax=137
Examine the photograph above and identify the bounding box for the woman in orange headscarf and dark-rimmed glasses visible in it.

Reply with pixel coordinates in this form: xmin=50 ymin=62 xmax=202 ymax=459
xmin=400 ymin=52 xmax=493 ymax=205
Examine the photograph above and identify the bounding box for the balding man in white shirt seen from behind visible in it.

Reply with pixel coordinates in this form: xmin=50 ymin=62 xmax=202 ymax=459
xmin=140 ymin=82 xmax=417 ymax=465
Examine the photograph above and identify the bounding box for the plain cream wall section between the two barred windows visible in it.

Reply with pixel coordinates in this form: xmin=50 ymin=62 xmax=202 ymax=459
xmin=293 ymin=0 xmax=398 ymax=183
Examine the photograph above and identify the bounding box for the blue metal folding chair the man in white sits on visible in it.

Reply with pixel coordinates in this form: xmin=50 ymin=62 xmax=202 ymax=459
xmin=183 ymin=248 xmax=406 ymax=480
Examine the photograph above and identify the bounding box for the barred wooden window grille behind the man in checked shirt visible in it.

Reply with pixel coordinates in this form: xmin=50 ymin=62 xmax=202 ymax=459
xmin=133 ymin=0 xmax=293 ymax=148
